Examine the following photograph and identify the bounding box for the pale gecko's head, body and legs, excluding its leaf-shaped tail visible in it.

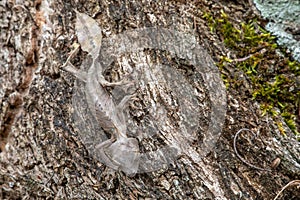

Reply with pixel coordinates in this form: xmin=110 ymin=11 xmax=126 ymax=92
xmin=65 ymin=51 xmax=139 ymax=175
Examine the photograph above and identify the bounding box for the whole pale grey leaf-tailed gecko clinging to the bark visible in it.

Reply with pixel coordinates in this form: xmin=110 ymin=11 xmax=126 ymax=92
xmin=64 ymin=12 xmax=139 ymax=175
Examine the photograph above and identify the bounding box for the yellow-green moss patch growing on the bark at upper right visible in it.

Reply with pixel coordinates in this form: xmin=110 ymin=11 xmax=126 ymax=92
xmin=203 ymin=11 xmax=300 ymax=136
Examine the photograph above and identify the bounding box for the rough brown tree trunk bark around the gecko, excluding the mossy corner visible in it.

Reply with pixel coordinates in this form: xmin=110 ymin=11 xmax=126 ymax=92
xmin=0 ymin=0 xmax=300 ymax=199
